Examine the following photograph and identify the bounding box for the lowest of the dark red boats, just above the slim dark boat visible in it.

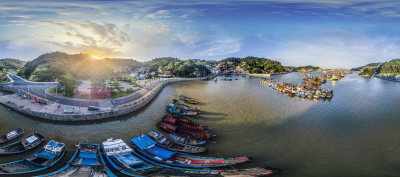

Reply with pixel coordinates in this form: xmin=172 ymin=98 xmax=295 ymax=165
xmin=158 ymin=122 xmax=214 ymax=140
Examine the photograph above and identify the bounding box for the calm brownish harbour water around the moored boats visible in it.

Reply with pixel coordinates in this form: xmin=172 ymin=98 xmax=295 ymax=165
xmin=0 ymin=73 xmax=400 ymax=177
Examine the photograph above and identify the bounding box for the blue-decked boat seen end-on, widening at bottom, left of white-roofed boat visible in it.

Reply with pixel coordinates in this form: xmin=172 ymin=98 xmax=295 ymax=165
xmin=40 ymin=143 xmax=116 ymax=177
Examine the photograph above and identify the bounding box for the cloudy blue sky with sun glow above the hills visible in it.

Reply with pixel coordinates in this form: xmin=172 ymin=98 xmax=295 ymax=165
xmin=0 ymin=0 xmax=400 ymax=68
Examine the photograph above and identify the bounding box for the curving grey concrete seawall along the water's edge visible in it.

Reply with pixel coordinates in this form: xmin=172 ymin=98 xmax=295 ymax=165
xmin=0 ymin=78 xmax=205 ymax=121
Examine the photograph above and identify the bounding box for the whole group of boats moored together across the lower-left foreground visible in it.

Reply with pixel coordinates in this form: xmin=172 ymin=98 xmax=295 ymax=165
xmin=0 ymin=100 xmax=279 ymax=177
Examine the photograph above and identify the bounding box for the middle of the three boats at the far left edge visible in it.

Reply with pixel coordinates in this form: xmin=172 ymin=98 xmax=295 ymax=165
xmin=0 ymin=132 xmax=46 ymax=154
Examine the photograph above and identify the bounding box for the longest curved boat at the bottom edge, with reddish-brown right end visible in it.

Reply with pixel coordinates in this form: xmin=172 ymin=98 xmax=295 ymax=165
xmin=133 ymin=151 xmax=280 ymax=177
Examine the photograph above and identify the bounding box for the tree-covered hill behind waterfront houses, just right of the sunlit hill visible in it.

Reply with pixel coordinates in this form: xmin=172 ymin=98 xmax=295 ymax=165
xmin=146 ymin=57 xmax=216 ymax=77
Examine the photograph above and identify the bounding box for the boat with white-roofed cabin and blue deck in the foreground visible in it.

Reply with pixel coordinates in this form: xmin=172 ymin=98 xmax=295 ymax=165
xmin=101 ymin=138 xmax=156 ymax=176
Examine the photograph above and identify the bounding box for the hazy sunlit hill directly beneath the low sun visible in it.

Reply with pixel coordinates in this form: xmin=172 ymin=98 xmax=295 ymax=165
xmin=18 ymin=52 xmax=142 ymax=81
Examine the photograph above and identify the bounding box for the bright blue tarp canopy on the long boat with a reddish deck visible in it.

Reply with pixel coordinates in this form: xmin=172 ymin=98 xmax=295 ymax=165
xmin=131 ymin=135 xmax=175 ymax=160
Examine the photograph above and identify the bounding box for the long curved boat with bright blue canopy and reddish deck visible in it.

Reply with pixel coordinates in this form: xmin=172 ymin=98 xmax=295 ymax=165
xmin=130 ymin=135 xmax=250 ymax=168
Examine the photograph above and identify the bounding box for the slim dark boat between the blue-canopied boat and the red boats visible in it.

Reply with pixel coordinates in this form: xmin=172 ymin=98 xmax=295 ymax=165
xmin=147 ymin=130 xmax=207 ymax=154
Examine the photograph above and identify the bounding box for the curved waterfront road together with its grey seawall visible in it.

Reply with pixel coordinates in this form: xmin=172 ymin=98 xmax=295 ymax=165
xmin=0 ymin=78 xmax=207 ymax=122
